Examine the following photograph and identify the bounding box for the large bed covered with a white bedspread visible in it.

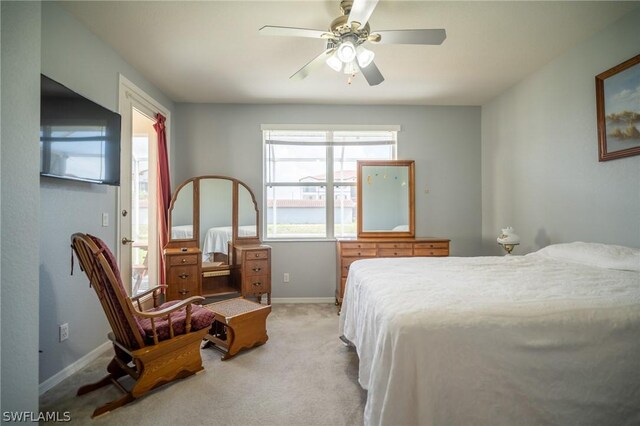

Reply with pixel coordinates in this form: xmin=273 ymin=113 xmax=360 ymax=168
xmin=340 ymin=243 xmax=640 ymax=425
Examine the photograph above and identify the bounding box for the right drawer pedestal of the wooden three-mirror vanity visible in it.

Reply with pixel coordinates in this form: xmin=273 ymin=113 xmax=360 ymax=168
xmin=233 ymin=244 xmax=271 ymax=305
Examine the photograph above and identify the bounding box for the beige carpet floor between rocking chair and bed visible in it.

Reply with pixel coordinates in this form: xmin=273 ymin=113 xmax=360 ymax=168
xmin=40 ymin=304 xmax=366 ymax=426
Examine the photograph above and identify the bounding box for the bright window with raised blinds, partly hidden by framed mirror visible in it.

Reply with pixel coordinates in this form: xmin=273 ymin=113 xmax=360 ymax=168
xmin=263 ymin=126 xmax=398 ymax=240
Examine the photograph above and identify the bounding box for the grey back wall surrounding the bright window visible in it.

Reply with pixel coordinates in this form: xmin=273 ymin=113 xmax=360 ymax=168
xmin=173 ymin=104 xmax=481 ymax=297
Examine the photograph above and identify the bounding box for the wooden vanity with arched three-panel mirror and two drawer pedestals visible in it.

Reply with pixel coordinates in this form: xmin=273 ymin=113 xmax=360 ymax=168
xmin=164 ymin=176 xmax=271 ymax=300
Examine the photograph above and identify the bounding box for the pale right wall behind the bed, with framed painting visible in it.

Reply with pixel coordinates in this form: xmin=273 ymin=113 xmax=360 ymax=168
xmin=482 ymin=9 xmax=640 ymax=254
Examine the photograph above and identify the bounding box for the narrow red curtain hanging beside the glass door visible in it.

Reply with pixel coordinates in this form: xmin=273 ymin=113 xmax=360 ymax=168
xmin=153 ymin=113 xmax=171 ymax=284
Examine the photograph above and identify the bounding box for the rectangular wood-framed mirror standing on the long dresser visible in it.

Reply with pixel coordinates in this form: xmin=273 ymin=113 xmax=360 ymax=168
xmin=357 ymin=160 xmax=415 ymax=238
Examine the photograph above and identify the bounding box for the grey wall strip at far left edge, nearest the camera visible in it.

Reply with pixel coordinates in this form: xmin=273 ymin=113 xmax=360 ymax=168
xmin=0 ymin=2 xmax=41 ymax=412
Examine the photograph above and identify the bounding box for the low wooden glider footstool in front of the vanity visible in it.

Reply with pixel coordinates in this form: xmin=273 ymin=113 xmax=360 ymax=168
xmin=204 ymin=297 xmax=271 ymax=361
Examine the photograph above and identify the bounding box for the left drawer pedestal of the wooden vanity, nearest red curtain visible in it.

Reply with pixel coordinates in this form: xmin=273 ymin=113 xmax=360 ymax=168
xmin=164 ymin=247 xmax=202 ymax=300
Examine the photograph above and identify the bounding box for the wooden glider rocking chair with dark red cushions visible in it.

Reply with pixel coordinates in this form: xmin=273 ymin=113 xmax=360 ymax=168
xmin=71 ymin=233 xmax=213 ymax=417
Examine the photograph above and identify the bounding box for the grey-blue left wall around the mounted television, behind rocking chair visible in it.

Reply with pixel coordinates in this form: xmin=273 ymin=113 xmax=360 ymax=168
xmin=39 ymin=2 xmax=173 ymax=382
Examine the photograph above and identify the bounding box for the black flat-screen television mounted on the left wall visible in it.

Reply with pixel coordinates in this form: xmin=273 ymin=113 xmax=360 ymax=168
xmin=40 ymin=75 xmax=120 ymax=186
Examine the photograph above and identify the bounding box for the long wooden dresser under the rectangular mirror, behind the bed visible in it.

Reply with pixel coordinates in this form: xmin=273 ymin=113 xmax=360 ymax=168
xmin=336 ymin=238 xmax=449 ymax=305
